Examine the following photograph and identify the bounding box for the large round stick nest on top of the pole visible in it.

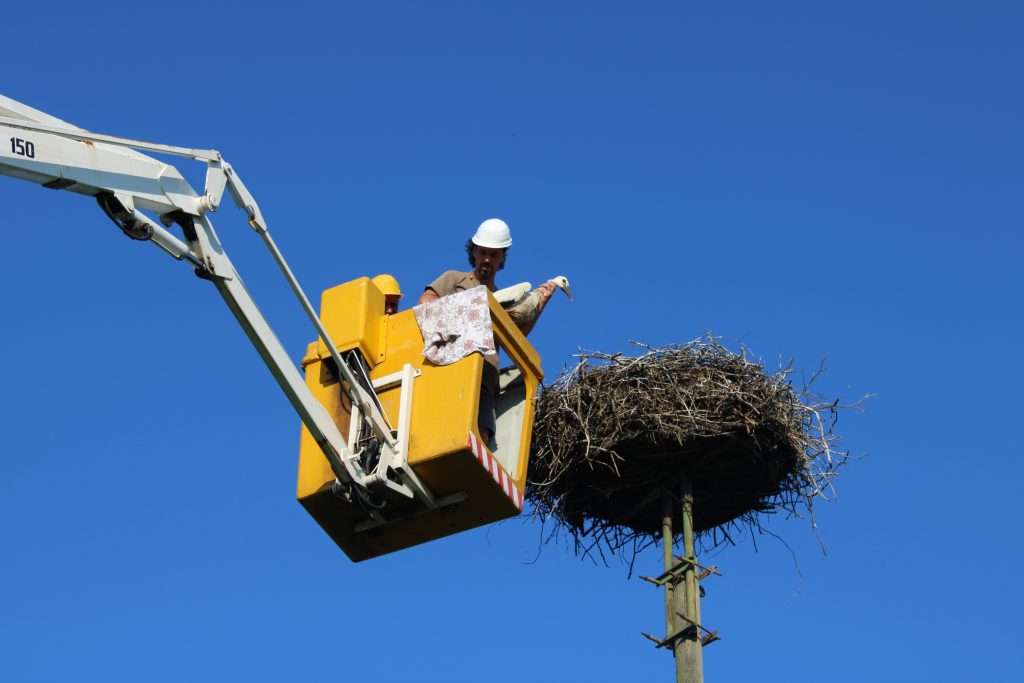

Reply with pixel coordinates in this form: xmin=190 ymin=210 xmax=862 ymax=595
xmin=526 ymin=337 xmax=849 ymax=561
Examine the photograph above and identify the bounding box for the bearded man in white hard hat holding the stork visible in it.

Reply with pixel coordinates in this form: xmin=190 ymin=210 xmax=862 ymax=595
xmin=420 ymin=218 xmax=555 ymax=442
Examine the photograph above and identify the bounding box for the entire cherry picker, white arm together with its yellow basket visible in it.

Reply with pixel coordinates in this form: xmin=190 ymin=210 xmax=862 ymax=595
xmin=0 ymin=95 xmax=541 ymax=560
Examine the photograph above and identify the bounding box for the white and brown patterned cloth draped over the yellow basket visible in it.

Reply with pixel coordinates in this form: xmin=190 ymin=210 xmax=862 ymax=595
xmin=413 ymin=285 xmax=498 ymax=366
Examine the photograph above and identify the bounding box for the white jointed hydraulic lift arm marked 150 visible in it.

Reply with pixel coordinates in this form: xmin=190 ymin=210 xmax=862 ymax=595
xmin=0 ymin=95 xmax=428 ymax=511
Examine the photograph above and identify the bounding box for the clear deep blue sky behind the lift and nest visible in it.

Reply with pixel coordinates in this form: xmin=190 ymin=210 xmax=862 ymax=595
xmin=0 ymin=1 xmax=1024 ymax=683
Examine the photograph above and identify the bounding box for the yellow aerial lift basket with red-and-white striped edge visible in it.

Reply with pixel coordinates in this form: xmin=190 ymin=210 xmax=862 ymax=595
xmin=297 ymin=278 xmax=543 ymax=561
